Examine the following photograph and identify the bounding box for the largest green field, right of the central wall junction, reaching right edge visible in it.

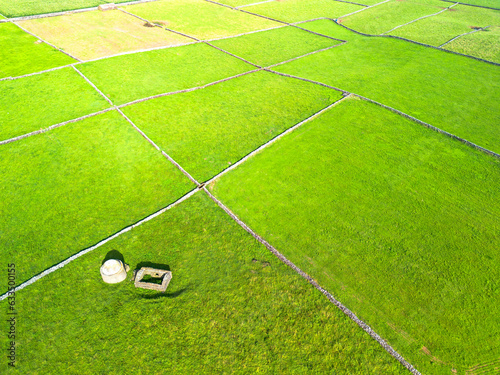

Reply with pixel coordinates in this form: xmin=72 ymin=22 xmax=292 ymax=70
xmin=211 ymin=100 xmax=500 ymax=374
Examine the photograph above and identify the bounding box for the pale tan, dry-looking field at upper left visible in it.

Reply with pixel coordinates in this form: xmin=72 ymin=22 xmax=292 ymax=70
xmin=20 ymin=10 xmax=192 ymax=60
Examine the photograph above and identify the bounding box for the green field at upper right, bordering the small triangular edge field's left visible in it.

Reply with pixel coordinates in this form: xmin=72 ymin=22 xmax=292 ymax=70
xmin=388 ymin=5 xmax=500 ymax=47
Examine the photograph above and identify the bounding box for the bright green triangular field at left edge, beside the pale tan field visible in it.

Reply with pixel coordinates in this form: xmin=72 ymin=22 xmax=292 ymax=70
xmin=0 ymin=23 xmax=76 ymax=78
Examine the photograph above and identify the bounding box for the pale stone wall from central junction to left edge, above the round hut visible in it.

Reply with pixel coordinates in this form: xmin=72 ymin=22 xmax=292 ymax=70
xmin=0 ymin=187 xmax=200 ymax=301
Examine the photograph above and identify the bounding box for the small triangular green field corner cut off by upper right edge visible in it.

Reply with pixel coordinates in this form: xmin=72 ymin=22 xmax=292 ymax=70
xmin=443 ymin=26 xmax=500 ymax=63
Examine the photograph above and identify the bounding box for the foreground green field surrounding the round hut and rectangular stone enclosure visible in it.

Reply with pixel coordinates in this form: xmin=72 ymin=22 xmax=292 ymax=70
xmin=0 ymin=192 xmax=406 ymax=375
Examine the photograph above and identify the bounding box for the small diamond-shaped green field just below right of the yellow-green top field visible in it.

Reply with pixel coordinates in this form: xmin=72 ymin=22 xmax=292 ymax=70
xmin=212 ymin=27 xmax=340 ymax=66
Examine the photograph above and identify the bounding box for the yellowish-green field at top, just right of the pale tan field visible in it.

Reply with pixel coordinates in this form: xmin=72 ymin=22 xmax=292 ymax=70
xmin=123 ymin=0 xmax=279 ymax=39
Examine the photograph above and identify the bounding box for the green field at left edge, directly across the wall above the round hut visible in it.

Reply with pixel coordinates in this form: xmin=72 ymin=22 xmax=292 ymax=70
xmin=0 ymin=112 xmax=194 ymax=290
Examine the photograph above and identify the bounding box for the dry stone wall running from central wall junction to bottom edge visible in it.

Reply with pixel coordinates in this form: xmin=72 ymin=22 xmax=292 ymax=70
xmin=203 ymin=187 xmax=420 ymax=375
